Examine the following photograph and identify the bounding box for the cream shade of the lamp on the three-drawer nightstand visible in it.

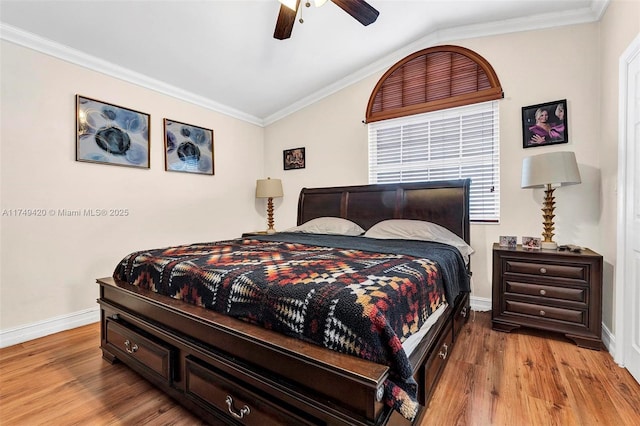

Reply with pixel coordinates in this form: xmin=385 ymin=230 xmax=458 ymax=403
xmin=521 ymin=151 xmax=581 ymax=188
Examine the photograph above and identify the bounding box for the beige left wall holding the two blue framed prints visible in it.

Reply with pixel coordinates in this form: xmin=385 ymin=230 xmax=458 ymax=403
xmin=0 ymin=41 xmax=264 ymax=331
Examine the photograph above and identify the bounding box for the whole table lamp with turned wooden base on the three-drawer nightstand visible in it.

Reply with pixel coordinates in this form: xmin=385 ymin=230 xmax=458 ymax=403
xmin=521 ymin=151 xmax=581 ymax=250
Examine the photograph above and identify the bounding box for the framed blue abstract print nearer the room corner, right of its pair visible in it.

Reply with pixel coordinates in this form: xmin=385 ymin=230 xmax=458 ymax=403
xmin=164 ymin=118 xmax=214 ymax=175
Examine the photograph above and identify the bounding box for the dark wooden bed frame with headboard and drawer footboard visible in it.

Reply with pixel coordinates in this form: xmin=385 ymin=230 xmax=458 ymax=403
xmin=97 ymin=179 xmax=470 ymax=425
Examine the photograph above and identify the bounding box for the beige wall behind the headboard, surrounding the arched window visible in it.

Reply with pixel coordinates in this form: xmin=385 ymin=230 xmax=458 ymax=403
xmin=265 ymin=15 xmax=631 ymax=332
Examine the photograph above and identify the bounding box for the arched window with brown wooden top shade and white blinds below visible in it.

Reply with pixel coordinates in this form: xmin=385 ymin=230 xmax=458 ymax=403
xmin=366 ymin=46 xmax=503 ymax=222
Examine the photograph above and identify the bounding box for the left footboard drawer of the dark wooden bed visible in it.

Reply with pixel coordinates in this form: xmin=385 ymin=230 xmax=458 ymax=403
xmin=106 ymin=319 xmax=174 ymax=382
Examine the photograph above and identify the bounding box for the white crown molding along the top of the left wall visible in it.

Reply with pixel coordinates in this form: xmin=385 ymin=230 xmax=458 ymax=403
xmin=0 ymin=22 xmax=264 ymax=127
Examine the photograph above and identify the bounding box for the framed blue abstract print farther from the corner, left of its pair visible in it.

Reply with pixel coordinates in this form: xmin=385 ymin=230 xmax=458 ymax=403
xmin=76 ymin=95 xmax=150 ymax=169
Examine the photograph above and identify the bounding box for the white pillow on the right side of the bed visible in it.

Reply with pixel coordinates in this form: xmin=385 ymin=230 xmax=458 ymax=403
xmin=364 ymin=219 xmax=474 ymax=260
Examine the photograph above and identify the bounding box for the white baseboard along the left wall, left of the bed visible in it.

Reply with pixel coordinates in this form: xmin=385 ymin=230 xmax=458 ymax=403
xmin=0 ymin=306 xmax=100 ymax=348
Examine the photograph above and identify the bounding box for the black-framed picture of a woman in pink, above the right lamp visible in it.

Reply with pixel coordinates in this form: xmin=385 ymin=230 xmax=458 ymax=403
xmin=522 ymin=99 xmax=569 ymax=148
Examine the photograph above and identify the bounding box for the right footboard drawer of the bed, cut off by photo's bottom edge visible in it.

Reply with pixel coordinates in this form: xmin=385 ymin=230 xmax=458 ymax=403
xmin=185 ymin=356 xmax=318 ymax=426
